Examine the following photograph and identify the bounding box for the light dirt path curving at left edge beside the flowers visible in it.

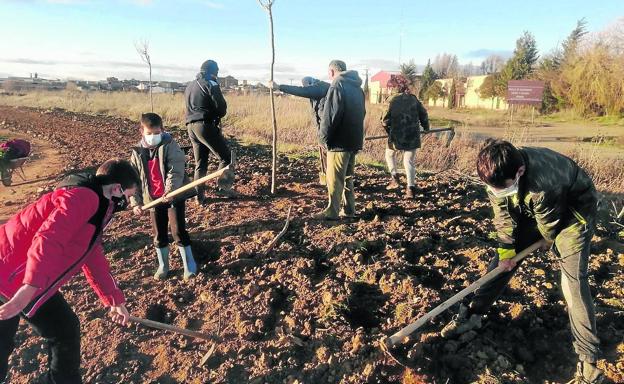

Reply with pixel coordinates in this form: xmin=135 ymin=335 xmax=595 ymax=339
xmin=0 ymin=124 xmax=63 ymax=223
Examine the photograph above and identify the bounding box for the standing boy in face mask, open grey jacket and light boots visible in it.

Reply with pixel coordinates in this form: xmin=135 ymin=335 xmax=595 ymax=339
xmin=130 ymin=113 xmax=197 ymax=280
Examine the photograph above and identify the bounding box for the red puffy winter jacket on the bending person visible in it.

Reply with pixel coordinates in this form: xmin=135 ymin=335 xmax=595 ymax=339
xmin=0 ymin=187 xmax=125 ymax=317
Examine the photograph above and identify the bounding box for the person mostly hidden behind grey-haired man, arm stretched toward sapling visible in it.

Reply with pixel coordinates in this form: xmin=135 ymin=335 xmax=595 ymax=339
xmin=269 ymin=76 xmax=329 ymax=185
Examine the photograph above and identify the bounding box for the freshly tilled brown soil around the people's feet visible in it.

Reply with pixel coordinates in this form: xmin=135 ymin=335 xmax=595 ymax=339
xmin=0 ymin=107 xmax=624 ymax=383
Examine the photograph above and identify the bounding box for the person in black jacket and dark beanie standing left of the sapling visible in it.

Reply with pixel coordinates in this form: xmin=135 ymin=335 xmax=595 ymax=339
xmin=184 ymin=60 xmax=234 ymax=203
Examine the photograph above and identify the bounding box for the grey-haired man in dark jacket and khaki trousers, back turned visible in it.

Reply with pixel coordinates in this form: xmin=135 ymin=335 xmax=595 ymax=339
xmin=315 ymin=60 xmax=366 ymax=220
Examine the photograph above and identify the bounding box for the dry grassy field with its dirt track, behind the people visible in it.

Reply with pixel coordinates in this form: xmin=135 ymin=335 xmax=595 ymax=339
xmin=0 ymin=91 xmax=624 ymax=193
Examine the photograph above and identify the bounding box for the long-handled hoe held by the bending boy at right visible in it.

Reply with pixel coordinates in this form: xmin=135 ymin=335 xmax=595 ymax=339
xmin=381 ymin=240 xmax=547 ymax=366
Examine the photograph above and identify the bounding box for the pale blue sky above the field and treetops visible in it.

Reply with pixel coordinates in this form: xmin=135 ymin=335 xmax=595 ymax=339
xmin=0 ymin=0 xmax=624 ymax=82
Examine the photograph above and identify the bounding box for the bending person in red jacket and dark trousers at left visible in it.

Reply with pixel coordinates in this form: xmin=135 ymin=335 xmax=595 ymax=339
xmin=0 ymin=159 xmax=140 ymax=384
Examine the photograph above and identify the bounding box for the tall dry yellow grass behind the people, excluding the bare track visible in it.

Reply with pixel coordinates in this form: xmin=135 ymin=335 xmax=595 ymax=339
xmin=0 ymin=91 xmax=624 ymax=193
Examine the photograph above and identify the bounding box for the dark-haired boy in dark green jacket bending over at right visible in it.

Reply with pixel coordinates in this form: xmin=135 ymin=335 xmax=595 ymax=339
xmin=442 ymin=140 xmax=603 ymax=384
